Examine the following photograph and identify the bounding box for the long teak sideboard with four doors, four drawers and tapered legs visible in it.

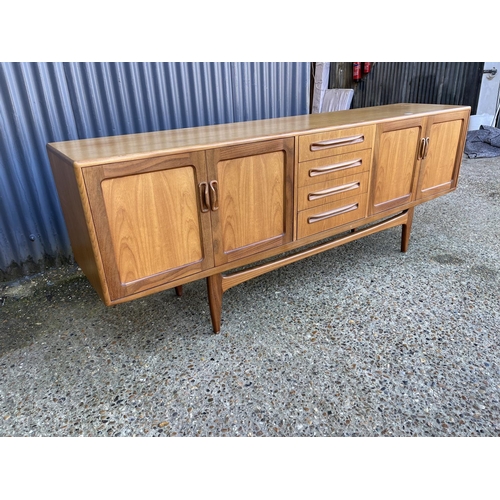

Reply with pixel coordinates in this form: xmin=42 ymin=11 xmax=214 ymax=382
xmin=47 ymin=104 xmax=470 ymax=333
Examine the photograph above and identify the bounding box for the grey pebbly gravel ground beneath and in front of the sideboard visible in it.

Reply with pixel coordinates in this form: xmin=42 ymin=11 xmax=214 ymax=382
xmin=0 ymin=154 xmax=500 ymax=437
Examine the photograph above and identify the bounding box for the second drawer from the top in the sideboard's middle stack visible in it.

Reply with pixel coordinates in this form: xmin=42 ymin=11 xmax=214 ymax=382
xmin=298 ymin=149 xmax=372 ymax=187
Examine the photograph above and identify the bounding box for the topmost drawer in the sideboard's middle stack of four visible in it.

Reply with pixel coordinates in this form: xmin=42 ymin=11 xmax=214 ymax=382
xmin=299 ymin=125 xmax=375 ymax=161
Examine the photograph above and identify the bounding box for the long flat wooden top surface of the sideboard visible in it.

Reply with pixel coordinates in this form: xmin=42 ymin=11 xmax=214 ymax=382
xmin=47 ymin=104 xmax=468 ymax=167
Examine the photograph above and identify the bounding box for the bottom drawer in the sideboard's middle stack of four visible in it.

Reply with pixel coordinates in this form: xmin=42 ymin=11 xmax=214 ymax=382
xmin=297 ymin=193 xmax=368 ymax=239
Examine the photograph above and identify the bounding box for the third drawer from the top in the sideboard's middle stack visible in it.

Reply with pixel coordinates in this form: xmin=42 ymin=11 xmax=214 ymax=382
xmin=298 ymin=172 xmax=369 ymax=210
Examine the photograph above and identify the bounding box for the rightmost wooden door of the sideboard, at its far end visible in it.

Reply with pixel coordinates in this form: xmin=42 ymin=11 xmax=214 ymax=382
xmin=417 ymin=111 xmax=469 ymax=199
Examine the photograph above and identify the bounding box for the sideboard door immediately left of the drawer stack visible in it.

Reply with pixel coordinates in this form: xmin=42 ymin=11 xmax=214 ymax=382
xmin=207 ymin=138 xmax=294 ymax=265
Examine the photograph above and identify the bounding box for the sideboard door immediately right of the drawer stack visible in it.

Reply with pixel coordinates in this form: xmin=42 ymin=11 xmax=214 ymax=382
xmin=370 ymin=118 xmax=423 ymax=214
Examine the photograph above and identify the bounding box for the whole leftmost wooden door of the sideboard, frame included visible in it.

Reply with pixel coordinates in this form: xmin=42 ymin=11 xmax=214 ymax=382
xmin=83 ymin=152 xmax=213 ymax=300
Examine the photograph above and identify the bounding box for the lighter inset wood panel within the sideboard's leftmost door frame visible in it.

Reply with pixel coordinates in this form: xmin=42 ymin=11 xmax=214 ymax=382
xmin=101 ymin=167 xmax=203 ymax=283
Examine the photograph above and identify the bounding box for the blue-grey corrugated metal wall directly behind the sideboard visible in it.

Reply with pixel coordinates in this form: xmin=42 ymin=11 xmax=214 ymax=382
xmin=0 ymin=62 xmax=310 ymax=281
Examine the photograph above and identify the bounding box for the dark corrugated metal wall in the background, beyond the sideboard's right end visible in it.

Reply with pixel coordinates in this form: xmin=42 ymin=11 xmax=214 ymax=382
xmin=329 ymin=62 xmax=484 ymax=114
